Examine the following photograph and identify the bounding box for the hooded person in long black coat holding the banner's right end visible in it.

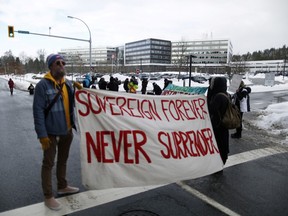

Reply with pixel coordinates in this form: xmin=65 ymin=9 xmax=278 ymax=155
xmin=207 ymin=77 xmax=229 ymax=164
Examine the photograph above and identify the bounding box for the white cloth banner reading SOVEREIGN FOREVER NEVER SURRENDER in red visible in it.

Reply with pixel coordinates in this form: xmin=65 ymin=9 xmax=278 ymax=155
xmin=75 ymin=89 xmax=223 ymax=189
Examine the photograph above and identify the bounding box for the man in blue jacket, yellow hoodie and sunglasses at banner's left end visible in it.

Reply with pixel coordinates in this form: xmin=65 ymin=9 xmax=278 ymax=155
xmin=33 ymin=54 xmax=81 ymax=210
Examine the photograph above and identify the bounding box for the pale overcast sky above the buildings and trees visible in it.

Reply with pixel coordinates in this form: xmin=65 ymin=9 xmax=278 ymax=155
xmin=0 ymin=0 xmax=288 ymax=57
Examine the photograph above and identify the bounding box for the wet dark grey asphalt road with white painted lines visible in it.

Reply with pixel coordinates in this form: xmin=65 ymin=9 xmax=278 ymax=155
xmin=0 ymin=79 xmax=288 ymax=216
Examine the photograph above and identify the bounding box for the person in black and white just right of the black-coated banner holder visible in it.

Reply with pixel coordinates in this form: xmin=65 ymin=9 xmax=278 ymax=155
xmin=231 ymin=80 xmax=251 ymax=139
